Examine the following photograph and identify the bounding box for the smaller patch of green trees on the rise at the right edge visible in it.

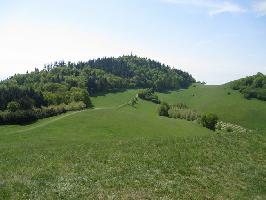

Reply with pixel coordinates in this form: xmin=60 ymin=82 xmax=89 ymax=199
xmin=231 ymin=73 xmax=266 ymax=101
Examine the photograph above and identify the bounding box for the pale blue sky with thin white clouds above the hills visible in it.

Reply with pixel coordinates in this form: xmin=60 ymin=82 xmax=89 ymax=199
xmin=0 ymin=0 xmax=266 ymax=84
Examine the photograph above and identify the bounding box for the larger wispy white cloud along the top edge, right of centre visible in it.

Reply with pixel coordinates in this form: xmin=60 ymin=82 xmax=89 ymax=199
xmin=162 ymin=0 xmax=246 ymax=15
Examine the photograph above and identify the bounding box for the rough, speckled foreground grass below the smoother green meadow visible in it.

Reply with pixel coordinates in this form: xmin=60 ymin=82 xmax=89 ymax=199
xmin=0 ymin=131 xmax=266 ymax=199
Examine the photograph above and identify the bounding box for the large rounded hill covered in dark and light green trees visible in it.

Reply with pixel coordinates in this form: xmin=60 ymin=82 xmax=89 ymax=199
xmin=0 ymin=55 xmax=195 ymax=124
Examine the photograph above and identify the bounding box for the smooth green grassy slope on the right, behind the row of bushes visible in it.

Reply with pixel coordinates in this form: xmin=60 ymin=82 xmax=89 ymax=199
xmin=159 ymin=85 xmax=266 ymax=130
